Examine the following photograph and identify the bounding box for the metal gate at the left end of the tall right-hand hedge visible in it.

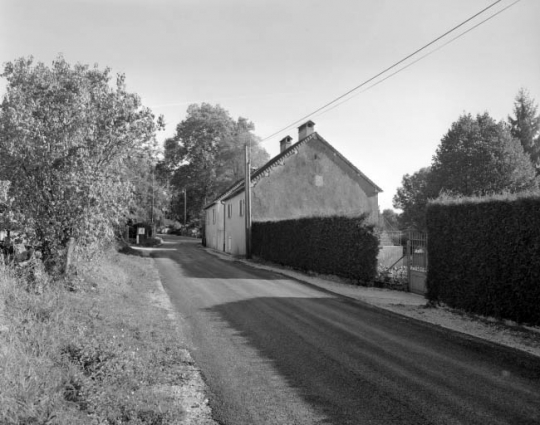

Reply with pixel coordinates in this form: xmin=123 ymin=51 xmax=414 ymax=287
xmin=407 ymin=231 xmax=428 ymax=295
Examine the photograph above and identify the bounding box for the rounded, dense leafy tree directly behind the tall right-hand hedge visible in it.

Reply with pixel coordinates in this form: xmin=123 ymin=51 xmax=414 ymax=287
xmin=431 ymin=113 xmax=536 ymax=196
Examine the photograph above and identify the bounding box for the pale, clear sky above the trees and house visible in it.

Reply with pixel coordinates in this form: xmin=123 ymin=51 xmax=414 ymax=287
xmin=0 ymin=0 xmax=540 ymax=210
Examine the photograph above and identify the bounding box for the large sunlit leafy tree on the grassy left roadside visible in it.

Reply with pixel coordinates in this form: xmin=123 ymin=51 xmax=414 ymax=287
xmin=0 ymin=57 xmax=162 ymax=260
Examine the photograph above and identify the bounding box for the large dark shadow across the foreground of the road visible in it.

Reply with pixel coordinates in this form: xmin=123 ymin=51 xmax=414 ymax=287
xmin=201 ymin=297 xmax=540 ymax=424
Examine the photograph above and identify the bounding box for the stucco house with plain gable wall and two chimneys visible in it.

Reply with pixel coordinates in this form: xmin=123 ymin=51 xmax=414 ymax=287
xmin=205 ymin=121 xmax=382 ymax=256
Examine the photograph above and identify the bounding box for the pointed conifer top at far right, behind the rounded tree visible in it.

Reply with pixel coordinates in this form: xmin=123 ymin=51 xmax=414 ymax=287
xmin=508 ymin=89 xmax=540 ymax=169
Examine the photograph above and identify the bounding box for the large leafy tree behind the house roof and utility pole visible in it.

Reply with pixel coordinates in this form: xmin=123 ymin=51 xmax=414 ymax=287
xmin=163 ymin=103 xmax=268 ymax=219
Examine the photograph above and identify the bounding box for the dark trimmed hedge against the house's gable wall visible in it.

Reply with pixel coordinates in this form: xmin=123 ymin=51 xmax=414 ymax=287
xmin=252 ymin=215 xmax=379 ymax=284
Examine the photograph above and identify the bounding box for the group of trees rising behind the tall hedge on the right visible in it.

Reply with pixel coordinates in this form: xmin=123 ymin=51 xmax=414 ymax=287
xmin=392 ymin=89 xmax=540 ymax=230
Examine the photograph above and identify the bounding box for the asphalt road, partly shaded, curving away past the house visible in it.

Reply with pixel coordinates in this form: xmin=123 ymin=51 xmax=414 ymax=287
xmin=152 ymin=236 xmax=540 ymax=425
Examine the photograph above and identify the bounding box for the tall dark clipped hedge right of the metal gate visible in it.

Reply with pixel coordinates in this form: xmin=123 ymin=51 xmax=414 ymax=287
xmin=426 ymin=196 xmax=540 ymax=325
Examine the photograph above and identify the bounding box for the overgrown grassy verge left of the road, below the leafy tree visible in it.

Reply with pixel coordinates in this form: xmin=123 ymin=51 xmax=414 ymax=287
xmin=0 ymin=245 xmax=190 ymax=425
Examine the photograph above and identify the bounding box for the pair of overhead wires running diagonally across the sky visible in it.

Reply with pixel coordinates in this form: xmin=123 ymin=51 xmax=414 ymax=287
xmin=261 ymin=0 xmax=520 ymax=142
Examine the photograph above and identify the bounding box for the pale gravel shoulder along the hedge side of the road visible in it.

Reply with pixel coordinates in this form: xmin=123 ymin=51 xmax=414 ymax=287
xmin=203 ymin=248 xmax=540 ymax=357
